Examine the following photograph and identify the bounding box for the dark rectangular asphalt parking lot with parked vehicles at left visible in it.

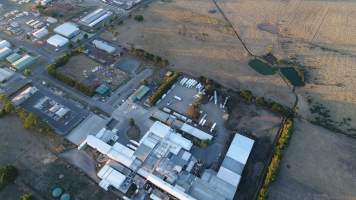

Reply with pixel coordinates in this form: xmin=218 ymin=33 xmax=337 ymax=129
xmin=21 ymin=88 xmax=88 ymax=135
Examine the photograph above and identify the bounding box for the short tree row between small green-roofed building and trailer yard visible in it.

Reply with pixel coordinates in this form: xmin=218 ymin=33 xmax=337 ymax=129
xmin=148 ymin=72 xmax=179 ymax=106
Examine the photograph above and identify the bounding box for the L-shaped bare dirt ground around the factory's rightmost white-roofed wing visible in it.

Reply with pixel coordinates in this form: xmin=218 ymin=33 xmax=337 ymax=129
xmin=227 ymin=95 xmax=282 ymax=200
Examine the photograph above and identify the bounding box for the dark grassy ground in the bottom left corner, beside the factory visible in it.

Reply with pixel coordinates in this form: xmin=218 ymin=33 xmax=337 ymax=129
xmin=0 ymin=116 xmax=116 ymax=200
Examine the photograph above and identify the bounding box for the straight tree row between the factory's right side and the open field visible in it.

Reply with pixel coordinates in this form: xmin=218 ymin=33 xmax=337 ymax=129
xmin=258 ymin=118 xmax=294 ymax=200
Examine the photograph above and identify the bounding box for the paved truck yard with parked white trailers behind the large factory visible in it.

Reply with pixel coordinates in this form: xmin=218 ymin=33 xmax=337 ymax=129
xmin=156 ymin=77 xmax=231 ymax=167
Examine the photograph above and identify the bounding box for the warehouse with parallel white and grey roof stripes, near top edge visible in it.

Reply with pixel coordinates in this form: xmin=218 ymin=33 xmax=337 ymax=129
xmin=79 ymin=8 xmax=113 ymax=28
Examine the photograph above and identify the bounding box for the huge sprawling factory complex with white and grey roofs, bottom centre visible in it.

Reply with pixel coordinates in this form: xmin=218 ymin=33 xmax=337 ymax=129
xmin=78 ymin=121 xmax=254 ymax=200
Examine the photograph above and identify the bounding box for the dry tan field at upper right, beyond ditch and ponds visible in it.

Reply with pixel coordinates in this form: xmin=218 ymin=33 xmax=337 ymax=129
xmin=219 ymin=0 xmax=356 ymax=134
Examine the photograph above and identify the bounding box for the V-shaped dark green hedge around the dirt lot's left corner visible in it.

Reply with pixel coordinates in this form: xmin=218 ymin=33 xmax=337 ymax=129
xmin=47 ymin=48 xmax=95 ymax=96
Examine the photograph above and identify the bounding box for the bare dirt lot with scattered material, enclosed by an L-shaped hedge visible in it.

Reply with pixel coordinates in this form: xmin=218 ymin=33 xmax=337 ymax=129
xmin=58 ymin=54 xmax=128 ymax=90
